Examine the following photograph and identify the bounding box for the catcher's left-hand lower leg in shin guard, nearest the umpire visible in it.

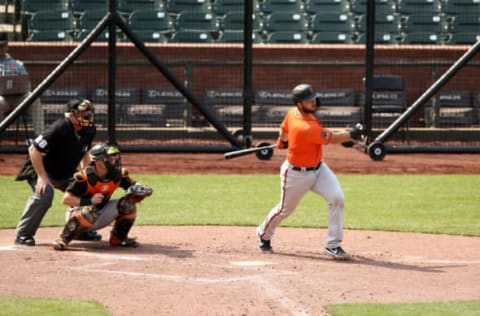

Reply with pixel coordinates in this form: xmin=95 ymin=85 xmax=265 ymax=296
xmin=53 ymin=206 xmax=97 ymax=250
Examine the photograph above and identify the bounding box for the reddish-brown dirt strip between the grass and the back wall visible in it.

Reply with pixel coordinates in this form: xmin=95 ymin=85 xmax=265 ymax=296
xmin=0 ymin=141 xmax=480 ymax=175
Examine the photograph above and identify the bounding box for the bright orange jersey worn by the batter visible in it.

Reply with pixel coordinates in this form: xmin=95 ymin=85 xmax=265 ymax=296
xmin=281 ymin=108 xmax=332 ymax=167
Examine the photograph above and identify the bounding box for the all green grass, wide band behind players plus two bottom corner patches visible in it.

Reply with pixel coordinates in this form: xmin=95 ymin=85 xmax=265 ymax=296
xmin=0 ymin=174 xmax=480 ymax=316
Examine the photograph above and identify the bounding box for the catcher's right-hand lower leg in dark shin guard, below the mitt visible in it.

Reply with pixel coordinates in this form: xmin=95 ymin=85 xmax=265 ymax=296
xmin=110 ymin=198 xmax=138 ymax=247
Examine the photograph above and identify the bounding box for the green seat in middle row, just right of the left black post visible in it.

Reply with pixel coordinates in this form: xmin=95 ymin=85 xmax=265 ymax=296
xmin=128 ymin=10 xmax=173 ymax=34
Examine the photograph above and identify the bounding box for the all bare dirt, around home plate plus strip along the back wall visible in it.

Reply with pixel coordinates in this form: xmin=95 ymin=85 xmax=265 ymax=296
xmin=0 ymin=146 xmax=480 ymax=315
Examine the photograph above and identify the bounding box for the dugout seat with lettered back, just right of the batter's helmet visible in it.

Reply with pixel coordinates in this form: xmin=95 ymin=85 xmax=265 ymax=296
xmin=315 ymin=89 xmax=360 ymax=127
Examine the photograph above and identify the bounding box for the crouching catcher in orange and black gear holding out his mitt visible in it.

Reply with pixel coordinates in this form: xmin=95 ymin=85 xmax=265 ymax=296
xmin=53 ymin=144 xmax=153 ymax=250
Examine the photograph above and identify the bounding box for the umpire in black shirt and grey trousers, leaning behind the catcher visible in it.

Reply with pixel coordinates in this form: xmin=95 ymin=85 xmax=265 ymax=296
xmin=15 ymin=99 xmax=102 ymax=246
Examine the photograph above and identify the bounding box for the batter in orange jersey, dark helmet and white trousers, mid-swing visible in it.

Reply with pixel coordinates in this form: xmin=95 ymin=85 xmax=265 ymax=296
xmin=257 ymin=84 xmax=363 ymax=260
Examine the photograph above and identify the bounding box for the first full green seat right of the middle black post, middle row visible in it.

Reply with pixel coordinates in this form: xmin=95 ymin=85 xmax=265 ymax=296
xmin=264 ymin=12 xmax=309 ymax=32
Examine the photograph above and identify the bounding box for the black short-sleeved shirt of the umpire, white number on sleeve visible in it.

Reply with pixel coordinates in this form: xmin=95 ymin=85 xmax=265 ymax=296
xmin=33 ymin=119 xmax=96 ymax=180
